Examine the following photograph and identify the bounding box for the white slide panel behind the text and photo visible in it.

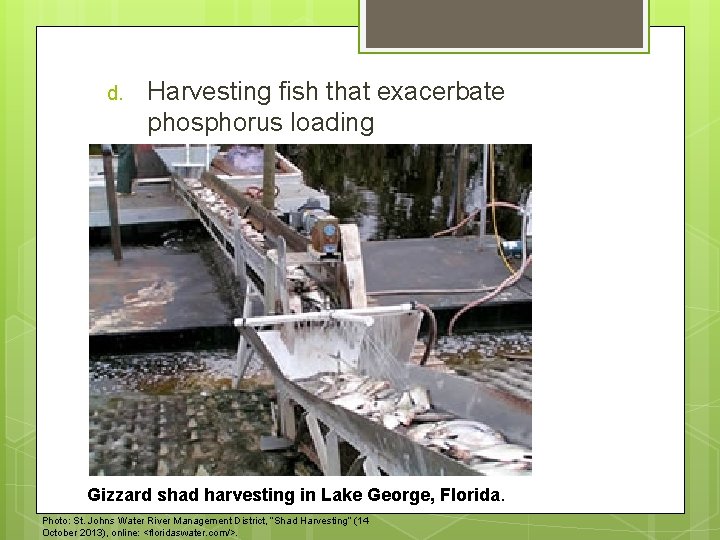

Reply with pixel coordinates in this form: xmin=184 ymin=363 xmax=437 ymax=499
xmin=37 ymin=28 xmax=684 ymax=513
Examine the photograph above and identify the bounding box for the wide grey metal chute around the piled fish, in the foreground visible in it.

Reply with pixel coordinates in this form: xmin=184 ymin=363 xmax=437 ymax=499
xmin=236 ymin=308 xmax=532 ymax=475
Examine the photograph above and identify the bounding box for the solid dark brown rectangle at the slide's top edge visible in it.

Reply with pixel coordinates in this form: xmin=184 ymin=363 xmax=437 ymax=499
xmin=361 ymin=0 xmax=646 ymax=51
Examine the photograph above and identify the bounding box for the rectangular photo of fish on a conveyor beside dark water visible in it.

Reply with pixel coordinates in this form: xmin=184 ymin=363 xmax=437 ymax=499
xmin=89 ymin=144 xmax=532 ymax=476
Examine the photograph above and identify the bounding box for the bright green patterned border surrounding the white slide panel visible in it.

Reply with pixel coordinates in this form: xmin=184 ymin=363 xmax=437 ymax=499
xmin=0 ymin=0 xmax=720 ymax=540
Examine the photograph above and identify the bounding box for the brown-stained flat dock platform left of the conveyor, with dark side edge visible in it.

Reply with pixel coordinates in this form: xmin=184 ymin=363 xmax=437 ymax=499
xmin=89 ymin=247 xmax=237 ymax=353
